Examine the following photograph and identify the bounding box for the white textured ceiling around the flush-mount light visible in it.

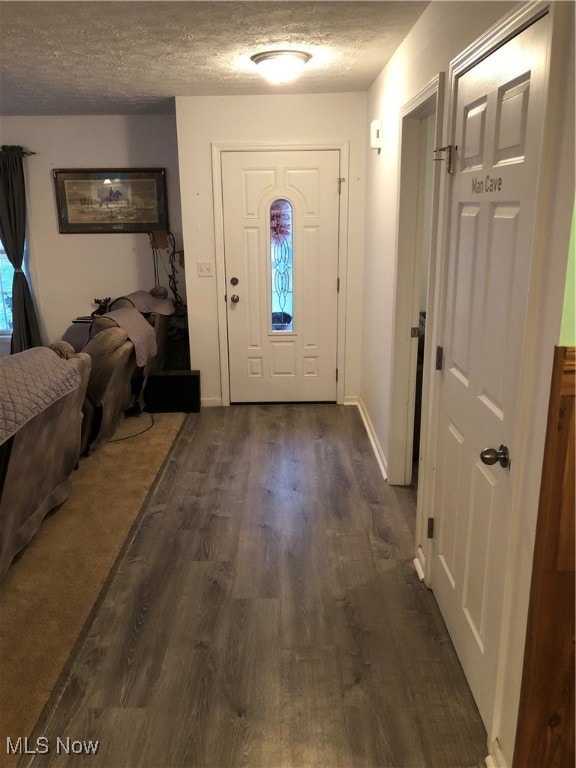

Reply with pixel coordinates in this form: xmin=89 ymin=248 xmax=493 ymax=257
xmin=0 ymin=0 xmax=428 ymax=115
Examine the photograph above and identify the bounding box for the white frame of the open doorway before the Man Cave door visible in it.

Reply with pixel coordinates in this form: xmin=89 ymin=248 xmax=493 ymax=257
xmin=387 ymin=72 xmax=446 ymax=579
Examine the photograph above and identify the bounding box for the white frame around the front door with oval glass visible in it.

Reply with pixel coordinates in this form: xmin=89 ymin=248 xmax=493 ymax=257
xmin=211 ymin=141 xmax=350 ymax=406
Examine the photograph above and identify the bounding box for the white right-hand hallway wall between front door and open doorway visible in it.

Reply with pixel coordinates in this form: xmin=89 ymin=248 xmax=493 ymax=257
xmin=360 ymin=2 xmax=514 ymax=468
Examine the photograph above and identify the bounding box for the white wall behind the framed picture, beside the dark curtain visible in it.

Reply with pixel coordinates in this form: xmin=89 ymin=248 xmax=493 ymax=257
xmin=0 ymin=115 xmax=182 ymax=343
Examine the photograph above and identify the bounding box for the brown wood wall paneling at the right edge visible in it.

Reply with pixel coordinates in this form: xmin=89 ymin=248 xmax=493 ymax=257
xmin=513 ymin=347 xmax=576 ymax=768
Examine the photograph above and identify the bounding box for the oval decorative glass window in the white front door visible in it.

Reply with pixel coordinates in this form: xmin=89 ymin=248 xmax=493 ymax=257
xmin=270 ymin=198 xmax=294 ymax=331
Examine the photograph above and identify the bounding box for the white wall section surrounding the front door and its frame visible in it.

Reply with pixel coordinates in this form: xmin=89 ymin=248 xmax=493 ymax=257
xmin=176 ymin=93 xmax=366 ymax=405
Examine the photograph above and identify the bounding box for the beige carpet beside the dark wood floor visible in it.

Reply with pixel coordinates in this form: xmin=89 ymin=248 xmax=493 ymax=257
xmin=0 ymin=413 xmax=185 ymax=768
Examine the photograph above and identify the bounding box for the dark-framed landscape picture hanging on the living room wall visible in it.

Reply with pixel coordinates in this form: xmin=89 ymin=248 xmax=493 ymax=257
xmin=53 ymin=168 xmax=169 ymax=235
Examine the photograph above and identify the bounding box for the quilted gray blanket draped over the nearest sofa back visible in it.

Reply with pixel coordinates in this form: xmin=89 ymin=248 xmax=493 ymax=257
xmin=0 ymin=347 xmax=80 ymax=445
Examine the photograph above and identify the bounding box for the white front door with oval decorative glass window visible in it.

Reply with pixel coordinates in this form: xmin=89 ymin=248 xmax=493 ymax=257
xmin=222 ymin=150 xmax=340 ymax=402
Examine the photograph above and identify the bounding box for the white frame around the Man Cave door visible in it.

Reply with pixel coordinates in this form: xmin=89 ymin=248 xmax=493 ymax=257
xmin=425 ymin=2 xmax=574 ymax=768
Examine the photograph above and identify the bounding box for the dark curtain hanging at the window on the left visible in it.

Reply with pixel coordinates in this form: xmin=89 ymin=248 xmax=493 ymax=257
xmin=0 ymin=146 xmax=42 ymax=353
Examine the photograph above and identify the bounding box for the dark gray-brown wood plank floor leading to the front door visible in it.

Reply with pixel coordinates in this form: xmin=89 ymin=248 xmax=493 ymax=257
xmin=21 ymin=405 xmax=487 ymax=768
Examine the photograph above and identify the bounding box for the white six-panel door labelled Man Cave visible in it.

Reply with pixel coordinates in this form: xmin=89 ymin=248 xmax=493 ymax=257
xmin=431 ymin=16 xmax=548 ymax=731
